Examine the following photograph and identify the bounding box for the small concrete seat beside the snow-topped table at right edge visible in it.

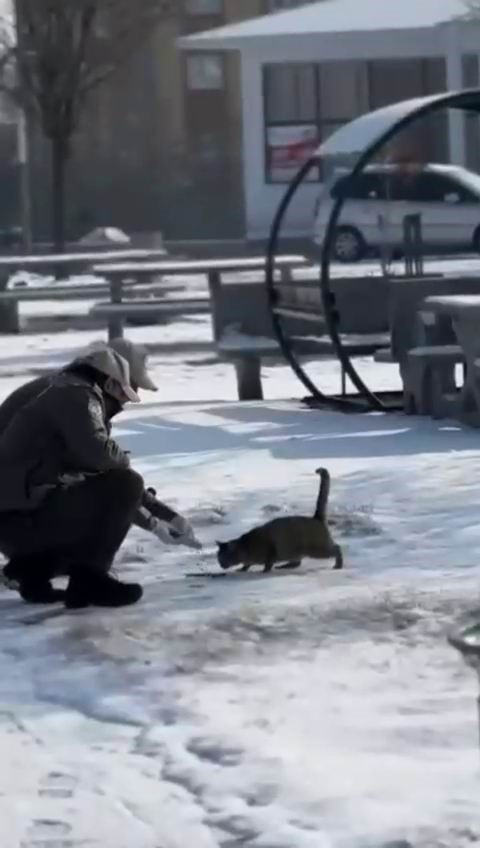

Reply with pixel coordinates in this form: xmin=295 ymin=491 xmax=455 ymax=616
xmin=403 ymin=345 xmax=465 ymax=418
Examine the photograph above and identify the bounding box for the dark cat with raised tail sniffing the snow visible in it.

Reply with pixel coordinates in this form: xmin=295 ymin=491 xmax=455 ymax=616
xmin=217 ymin=468 xmax=343 ymax=572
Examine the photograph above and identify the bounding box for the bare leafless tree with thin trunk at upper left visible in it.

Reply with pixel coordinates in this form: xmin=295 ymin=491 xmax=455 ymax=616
xmin=0 ymin=0 xmax=175 ymax=252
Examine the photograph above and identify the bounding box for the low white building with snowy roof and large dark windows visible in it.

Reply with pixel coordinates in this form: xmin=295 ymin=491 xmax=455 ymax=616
xmin=180 ymin=0 xmax=480 ymax=239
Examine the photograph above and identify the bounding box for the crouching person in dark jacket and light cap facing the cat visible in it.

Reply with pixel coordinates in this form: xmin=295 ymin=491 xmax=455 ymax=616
xmin=0 ymin=348 xmax=153 ymax=609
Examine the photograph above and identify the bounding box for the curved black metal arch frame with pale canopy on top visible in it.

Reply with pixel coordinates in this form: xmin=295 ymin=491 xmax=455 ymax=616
xmin=266 ymin=88 xmax=480 ymax=411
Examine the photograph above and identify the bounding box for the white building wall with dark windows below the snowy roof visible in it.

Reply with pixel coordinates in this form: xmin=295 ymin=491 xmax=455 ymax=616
xmin=242 ymin=34 xmax=480 ymax=239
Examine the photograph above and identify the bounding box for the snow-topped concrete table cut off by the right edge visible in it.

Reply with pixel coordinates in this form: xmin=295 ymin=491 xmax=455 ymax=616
xmin=422 ymin=294 xmax=480 ymax=426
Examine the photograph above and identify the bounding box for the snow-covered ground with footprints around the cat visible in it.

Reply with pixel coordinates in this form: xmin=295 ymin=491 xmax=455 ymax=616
xmin=0 ymin=266 xmax=480 ymax=848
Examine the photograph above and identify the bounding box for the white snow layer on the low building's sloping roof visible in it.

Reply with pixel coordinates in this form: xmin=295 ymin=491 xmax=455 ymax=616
xmin=180 ymin=0 xmax=468 ymax=49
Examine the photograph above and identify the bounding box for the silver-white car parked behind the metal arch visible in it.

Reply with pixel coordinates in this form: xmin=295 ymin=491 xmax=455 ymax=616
xmin=314 ymin=164 xmax=480 ymax=262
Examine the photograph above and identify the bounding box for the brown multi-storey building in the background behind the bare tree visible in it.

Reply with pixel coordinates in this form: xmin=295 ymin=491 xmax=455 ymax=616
xmin=24 ymin=0 xmax=314 ymax=245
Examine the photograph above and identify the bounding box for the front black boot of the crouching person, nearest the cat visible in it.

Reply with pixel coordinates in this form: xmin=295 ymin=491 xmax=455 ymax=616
xmin=65 ymin=569 xmax=143 ymax=609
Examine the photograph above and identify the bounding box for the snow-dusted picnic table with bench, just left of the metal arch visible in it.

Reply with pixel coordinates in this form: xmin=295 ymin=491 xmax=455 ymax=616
xmin=91 ymin=255 xmax=310 ymax=339
